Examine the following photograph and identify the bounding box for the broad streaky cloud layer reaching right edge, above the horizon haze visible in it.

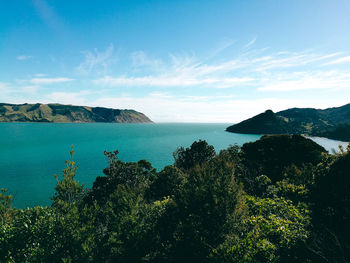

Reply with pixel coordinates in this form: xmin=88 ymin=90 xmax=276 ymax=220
xmin=93 ymin=47 xmax=350 ymax=91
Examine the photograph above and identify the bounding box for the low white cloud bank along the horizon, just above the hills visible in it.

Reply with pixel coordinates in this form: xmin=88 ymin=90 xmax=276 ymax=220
xmin=13 ymin=87 xmax=348 ymax=123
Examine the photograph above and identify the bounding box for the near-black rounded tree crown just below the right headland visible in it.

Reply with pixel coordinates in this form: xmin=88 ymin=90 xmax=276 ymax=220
xmin=239 ymin=135 xmax=326 ymax=194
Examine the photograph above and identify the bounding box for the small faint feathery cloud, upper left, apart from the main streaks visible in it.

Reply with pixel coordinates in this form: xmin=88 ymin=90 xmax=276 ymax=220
xmin=76 ymin=44 xmax=116 ymax=74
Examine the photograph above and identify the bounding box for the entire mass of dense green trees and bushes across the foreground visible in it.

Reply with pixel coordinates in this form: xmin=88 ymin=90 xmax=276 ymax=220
xmin=0 ymin=135 xmax=350 ymax=262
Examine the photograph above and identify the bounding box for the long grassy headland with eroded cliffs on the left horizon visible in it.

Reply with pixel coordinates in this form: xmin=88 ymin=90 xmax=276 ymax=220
xmin=0 ymin=103 xmax=152 ymax=123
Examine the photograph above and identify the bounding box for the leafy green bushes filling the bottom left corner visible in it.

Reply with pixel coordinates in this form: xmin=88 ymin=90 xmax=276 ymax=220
xmin=0 ymin=207 xmax=97 ymax=262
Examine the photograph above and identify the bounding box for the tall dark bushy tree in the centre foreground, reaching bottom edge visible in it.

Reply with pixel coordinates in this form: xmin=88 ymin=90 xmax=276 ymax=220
xmin=168 ymin=158 xmax=245 ymax=262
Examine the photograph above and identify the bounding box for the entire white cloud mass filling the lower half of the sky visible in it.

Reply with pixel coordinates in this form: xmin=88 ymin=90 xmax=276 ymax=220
xmin=4 ymin=42 xmax=350 ymax=123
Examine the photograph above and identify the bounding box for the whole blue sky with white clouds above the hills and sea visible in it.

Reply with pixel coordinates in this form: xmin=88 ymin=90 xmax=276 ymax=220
xmin=0 ymin=0 xmax=350 ymax=123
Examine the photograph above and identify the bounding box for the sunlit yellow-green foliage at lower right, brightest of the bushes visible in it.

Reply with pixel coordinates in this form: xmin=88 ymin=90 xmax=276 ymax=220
xmin=216 ymin=196 xmax=309 ymax=262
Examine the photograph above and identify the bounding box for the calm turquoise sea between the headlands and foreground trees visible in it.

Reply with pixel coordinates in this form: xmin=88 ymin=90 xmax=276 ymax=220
xmin=0 ymin=123 xmax=346 ymax=208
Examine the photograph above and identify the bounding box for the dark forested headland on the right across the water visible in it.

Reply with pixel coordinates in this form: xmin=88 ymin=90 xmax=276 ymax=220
xmin=226 ymin=104 xmax=350 ymax=141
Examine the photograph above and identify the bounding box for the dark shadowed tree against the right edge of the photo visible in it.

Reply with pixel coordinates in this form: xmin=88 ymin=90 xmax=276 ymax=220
xmin=308 ymin=152 xmax=350 ymax=262
